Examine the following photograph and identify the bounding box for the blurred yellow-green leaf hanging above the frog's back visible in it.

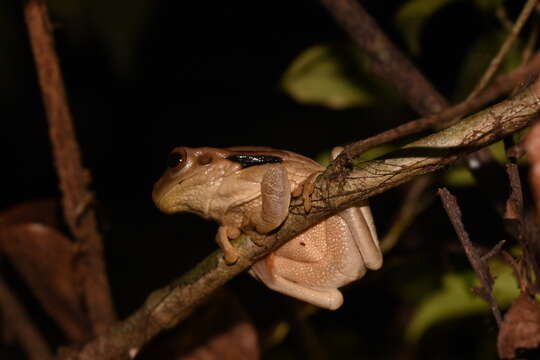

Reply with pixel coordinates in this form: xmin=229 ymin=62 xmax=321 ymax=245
xmin=281 ymin=45 xmax=382 ymax=109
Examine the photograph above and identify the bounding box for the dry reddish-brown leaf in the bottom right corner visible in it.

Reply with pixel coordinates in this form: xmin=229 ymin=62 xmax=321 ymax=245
xmin=497 ymin=293 xmax=540 ymax=359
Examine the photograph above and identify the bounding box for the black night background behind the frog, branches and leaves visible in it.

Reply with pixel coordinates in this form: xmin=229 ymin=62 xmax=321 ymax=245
xmin=0 ymin=0 xmax=519 ymax=359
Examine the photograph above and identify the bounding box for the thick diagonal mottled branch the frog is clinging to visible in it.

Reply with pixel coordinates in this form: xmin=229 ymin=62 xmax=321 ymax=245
xmin=63 ymin=71 xmax=540 ymax=360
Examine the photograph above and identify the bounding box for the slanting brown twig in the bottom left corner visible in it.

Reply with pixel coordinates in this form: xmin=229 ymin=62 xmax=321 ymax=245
xmin=0 ymin=277 xmax=53 ymax=360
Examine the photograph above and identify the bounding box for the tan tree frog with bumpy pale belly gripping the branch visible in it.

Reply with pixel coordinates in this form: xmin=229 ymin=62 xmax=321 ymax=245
xmin=152 ymin=147 xmax=382 ymax=310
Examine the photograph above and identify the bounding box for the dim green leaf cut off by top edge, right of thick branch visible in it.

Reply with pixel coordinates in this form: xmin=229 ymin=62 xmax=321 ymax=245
xmin=396 ymin=0 xmax=455 ymax=54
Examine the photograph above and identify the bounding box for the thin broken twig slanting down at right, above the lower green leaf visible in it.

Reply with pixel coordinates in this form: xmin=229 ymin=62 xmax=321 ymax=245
xmin=439 ymin=188 xmax=502 ymax=327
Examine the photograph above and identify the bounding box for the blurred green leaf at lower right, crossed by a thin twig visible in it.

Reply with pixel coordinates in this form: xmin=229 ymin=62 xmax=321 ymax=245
xmin=405 ymin=261 xmax=519 ymax=343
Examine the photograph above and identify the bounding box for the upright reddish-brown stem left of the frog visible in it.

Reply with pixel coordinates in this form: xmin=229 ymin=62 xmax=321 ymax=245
xmin=24 ymin=0 xmax=116 ymax=334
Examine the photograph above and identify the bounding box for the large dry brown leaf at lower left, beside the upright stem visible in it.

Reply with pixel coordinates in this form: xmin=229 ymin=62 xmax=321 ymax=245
xmin=0 ymin=223 xmax=90 ymax=341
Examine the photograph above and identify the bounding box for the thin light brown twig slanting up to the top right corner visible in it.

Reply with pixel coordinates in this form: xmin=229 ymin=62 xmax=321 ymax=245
xmin=467 ymin=0 xmax=538 ymax=100
